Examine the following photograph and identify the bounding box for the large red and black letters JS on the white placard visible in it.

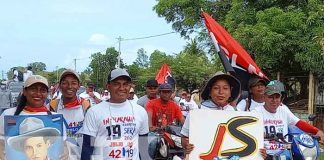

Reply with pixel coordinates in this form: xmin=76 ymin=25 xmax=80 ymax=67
xmin=199 ymin=116 xmax=258 ymax=160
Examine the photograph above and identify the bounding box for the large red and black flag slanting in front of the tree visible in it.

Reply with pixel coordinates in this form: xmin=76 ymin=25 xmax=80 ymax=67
xmin=202 ymin=12 xmax=268 ymax=90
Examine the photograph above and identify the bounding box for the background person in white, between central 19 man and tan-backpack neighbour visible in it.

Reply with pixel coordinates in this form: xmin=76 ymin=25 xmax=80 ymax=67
xmin=79 ymin=82 xmax=101 ymax=106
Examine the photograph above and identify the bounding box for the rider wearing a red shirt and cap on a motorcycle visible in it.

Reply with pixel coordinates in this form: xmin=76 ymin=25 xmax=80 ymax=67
xmin=146 ymin=83 xmax=184 ymax=131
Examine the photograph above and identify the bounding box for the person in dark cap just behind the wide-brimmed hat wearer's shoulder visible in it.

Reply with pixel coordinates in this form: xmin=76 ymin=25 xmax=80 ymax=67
xmin=236 ymin=75 xmax=267 ymax=111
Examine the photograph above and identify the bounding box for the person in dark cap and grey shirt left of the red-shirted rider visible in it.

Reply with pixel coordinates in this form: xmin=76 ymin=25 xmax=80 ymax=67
xmin=137 ymin=79 xmax=159 ymax=108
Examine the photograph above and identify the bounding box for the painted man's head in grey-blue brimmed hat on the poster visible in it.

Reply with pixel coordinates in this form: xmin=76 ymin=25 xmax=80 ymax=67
xmin=7 ymin=117 xmax=61 ymax=160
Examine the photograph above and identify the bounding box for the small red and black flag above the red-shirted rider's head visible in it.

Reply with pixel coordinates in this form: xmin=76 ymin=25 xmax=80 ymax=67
xmin=155 ymin=63 xmax=175 ymax=87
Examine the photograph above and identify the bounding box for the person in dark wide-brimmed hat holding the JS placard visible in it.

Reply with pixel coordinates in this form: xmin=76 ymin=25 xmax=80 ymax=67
xmin=181 ymin=71 xmax=241 ymax=154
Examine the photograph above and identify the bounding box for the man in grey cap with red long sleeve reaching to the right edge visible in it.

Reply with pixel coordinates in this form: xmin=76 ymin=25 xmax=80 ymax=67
xmin=253 ymin=82 xmax=324 ymax=158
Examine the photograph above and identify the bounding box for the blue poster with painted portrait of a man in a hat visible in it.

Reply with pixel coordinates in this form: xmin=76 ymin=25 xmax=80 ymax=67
xmin=4 ymin=115 xmax=63 ymax=160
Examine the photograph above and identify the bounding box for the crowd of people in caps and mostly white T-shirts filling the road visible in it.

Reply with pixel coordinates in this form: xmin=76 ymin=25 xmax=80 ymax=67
xmin=0 ymin=68 xmax=324 ymax=160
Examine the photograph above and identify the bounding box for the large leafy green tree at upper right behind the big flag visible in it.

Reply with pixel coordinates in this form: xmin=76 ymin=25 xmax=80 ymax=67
xmin=154 ymin=0 xmax=324 ymax=77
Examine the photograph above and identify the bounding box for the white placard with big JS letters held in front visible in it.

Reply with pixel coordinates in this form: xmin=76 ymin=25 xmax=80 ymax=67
xmin=189 ymin=109 xmax=264 ymax=160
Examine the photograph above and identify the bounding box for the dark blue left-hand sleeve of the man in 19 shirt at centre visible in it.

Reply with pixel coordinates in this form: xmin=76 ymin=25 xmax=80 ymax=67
xmin=81 ymin=134 xmax=95 ymax=160
